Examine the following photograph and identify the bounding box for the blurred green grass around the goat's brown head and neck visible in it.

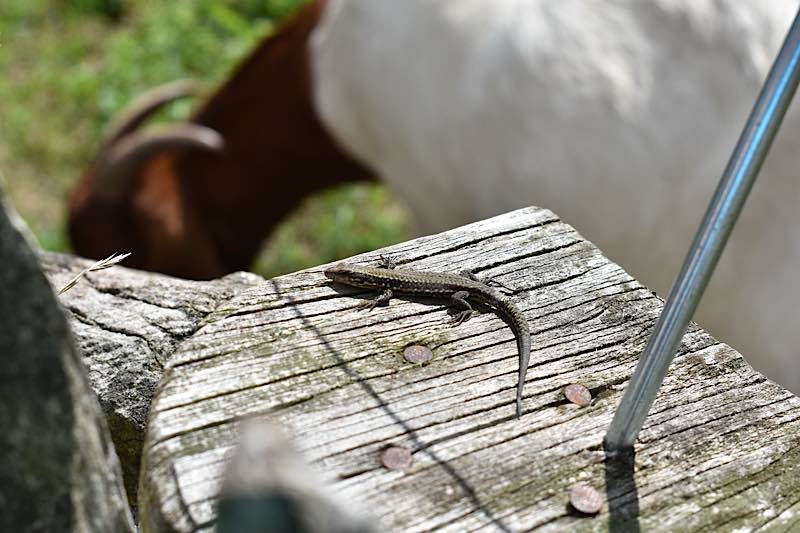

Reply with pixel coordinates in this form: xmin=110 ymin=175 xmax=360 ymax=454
xmin=0 ymin=0 xmax=410 ymax=277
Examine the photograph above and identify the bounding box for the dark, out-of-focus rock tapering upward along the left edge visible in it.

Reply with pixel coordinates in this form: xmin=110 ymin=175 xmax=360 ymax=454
xmin=0 ymin=186 xmax=133 ymax=532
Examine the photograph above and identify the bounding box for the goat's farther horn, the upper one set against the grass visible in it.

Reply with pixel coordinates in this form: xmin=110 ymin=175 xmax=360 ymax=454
xmin=98 ymin=80 xmax=202 ymax=157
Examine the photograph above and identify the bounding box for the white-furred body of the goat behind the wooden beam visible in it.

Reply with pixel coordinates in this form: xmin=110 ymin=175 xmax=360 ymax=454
xmin=312 ymin=0 xmax=800 ymax=392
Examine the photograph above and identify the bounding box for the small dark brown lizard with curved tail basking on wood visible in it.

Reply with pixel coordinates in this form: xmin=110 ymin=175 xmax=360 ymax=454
xmin=325 ymin=256 xmax=531 ymax=418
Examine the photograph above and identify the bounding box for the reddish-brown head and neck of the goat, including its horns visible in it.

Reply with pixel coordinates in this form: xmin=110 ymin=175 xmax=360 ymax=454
xmin=68 ymin=2 xmax=372 ymax=279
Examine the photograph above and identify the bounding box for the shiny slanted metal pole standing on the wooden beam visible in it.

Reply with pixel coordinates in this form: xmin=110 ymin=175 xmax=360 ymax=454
xmin=605 ymin=8 xmax=800 ymax=450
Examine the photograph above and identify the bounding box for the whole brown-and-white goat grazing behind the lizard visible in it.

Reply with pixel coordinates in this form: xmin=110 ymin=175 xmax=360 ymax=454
xmin=73 ymin=0 xmax=800 ymax=392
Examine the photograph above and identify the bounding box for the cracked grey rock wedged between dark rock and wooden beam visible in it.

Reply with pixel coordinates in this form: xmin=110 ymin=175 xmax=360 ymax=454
xmin=39 ymin=250 xmax=264 ymax=511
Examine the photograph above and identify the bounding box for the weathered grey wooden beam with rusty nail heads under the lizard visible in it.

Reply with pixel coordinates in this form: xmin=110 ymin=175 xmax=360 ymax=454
xmin=140 ymin=208 xmax=800 ymax=531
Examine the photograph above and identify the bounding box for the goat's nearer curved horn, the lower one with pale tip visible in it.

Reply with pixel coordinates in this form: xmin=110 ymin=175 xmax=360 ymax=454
xmin=95 ymin=123 xmax=225 ymax=198
